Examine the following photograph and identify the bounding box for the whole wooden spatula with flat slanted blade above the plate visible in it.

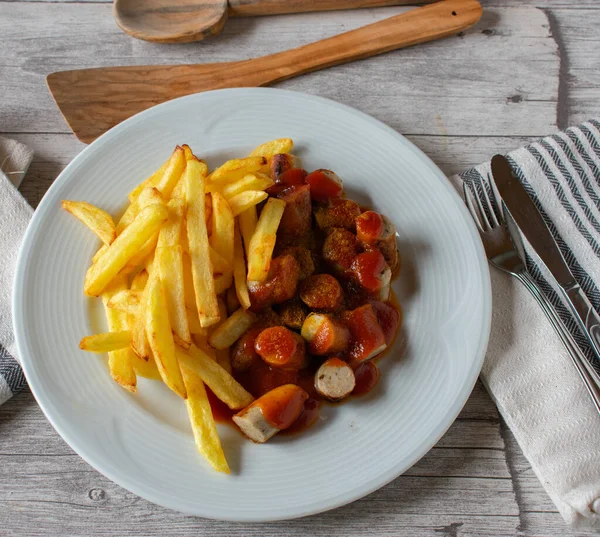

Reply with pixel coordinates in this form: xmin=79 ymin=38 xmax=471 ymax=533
xmin=47 ymin=0 xmax=482 ymax=143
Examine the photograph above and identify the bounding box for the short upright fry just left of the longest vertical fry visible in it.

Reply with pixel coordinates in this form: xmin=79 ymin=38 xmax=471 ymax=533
xmin=156 ymin=244 xmax=192 ymax=347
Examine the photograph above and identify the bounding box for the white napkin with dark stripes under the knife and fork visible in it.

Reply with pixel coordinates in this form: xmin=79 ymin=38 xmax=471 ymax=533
xmin=451 ymin=120 xmax=600 ymax=528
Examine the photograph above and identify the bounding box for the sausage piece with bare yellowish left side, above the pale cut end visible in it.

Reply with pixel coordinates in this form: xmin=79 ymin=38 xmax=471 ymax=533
xmin=301 ymin=313 xmax=350 ymax=356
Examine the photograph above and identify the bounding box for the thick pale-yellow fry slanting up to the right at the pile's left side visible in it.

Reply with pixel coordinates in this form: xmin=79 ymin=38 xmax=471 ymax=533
xmin=85 ymin=204 xmax=169 ymax=296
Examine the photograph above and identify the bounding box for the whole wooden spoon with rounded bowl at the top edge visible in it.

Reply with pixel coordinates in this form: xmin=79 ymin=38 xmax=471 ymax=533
xmin=113 ymin=0 xmax=433 ymax=43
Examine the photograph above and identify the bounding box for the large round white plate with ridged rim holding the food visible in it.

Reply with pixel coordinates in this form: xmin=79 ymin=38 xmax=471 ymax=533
xmin=13 ymin=89 xmax=491 ymax=521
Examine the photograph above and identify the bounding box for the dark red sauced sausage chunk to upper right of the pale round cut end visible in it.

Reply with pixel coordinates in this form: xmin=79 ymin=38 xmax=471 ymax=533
xmin=343 ymin=304 xmax=387 ymax=365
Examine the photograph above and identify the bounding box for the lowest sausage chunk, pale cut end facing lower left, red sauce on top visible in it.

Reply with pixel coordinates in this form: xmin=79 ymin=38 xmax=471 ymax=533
xmin=233 ymin=384 xmax=308 ymax=443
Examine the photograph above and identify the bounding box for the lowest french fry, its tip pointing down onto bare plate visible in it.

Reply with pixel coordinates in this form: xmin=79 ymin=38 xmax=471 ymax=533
xmin=181 ymin=366 xmax=230 ymax=474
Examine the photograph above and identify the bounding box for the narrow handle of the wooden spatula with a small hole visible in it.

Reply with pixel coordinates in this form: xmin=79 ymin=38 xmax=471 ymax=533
xmin=238 ymin=0 xmax=482 ymax=86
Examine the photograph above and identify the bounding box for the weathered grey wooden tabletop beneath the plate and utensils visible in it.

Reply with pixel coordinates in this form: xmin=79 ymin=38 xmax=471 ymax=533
xmin=0 ymin=0 xmax=600 ymax=537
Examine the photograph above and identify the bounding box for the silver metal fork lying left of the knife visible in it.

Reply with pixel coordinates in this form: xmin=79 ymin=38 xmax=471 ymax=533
xmin=463 ymin=183 xmax=600 ymax=412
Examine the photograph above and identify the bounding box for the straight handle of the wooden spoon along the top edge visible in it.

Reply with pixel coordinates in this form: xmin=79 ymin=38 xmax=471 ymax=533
xmin=229 ymin=0 xmax=435 ymax=17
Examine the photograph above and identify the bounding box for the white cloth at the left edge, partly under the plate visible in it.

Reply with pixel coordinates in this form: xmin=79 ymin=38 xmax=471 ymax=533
xmin=0 ymin=137 xmax=33 ymax=404
